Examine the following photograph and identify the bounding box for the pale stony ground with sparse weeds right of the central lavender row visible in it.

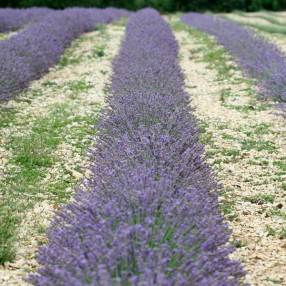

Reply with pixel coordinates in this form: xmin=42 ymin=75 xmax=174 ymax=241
xmin=175 ymin=21 xmax=286 ymax=286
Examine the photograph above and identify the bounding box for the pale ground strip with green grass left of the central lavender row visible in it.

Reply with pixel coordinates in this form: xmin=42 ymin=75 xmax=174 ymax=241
xmin=0 ymin=22 xmax=124 ymax=263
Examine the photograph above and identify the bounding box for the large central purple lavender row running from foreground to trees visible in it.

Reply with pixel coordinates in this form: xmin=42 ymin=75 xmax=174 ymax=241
xmin=30 ymin=9 xmax=243 ymax=286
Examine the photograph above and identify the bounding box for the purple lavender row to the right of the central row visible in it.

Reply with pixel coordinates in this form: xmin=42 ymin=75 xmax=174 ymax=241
xmin=182 ymin=13 xmax=286 ymax=101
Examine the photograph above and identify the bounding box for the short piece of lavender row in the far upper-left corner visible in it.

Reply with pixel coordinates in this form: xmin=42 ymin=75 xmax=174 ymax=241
xmin=0 ymin=8 xmax=53 ymax=33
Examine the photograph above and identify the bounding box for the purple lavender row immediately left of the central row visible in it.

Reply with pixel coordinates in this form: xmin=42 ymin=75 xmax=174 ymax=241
xmin=0 ymin=8 xmax=128 ymax=101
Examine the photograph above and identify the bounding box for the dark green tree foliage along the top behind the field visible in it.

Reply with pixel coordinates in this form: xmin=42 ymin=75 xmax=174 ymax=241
xmin=0 ymin=0 xmax=286 ymax=12
